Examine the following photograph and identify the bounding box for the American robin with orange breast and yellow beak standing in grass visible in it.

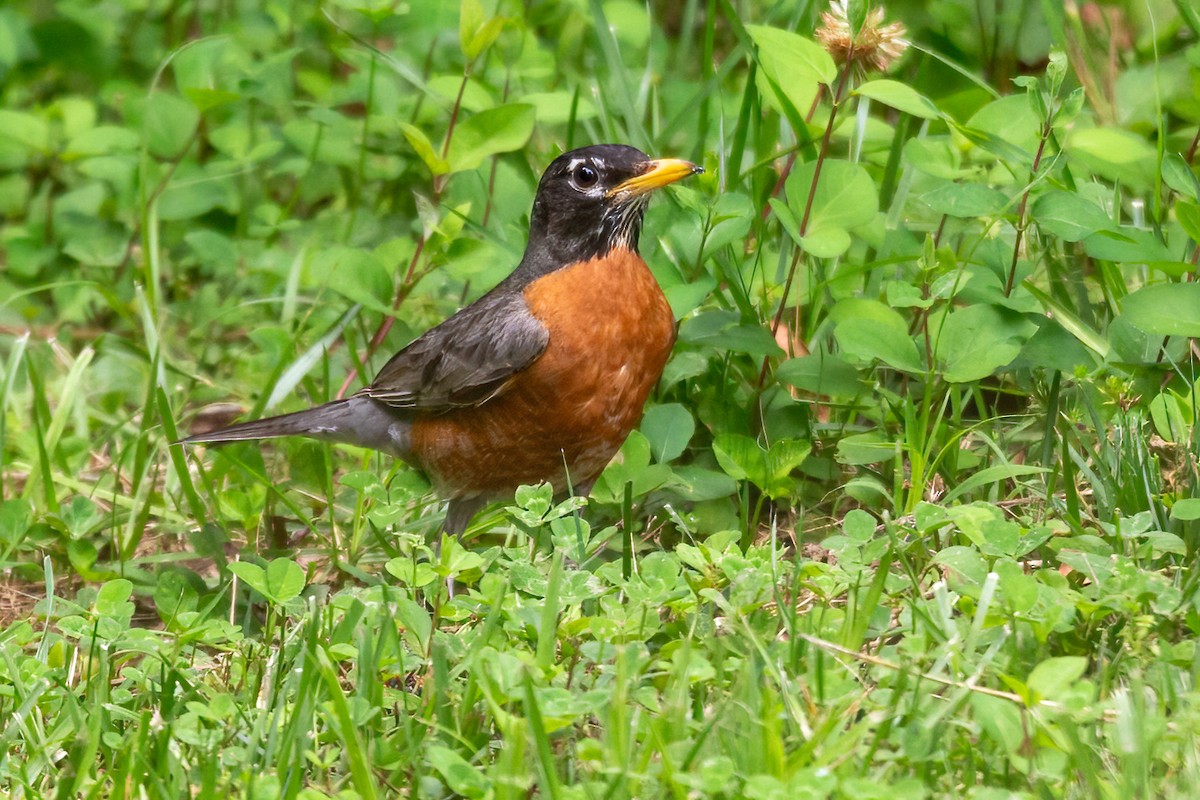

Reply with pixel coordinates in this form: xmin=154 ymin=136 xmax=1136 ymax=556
xmin=184 ymin=144 xmax=702 ymax=535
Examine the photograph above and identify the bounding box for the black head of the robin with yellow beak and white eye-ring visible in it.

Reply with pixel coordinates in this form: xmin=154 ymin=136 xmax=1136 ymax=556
xmin=514 ymin=144 xmax=703 ymax=279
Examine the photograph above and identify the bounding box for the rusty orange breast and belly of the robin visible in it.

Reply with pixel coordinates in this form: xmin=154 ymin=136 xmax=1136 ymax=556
xmin=413 ymin=251 xmax=676 ymax=498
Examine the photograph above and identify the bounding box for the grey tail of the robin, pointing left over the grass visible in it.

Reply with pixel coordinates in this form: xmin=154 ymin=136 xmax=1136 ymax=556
xmin=180 ymin=397 xmax=410 ymax=458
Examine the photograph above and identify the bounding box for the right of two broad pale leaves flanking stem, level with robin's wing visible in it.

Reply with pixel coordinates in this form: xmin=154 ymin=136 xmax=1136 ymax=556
xmin=931 ymin=305 xmax=1037 ymax=384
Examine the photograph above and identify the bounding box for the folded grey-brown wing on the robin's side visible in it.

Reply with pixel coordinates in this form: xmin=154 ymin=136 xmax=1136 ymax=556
xmin=358 ymin=291 xmax=550 ymax=413
